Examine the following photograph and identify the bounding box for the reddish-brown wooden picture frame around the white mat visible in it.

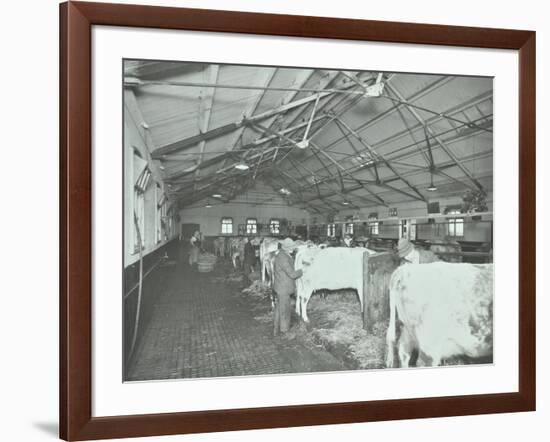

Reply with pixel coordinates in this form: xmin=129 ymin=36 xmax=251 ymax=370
xmin=60 ymin=2 xmax=536 ymax=440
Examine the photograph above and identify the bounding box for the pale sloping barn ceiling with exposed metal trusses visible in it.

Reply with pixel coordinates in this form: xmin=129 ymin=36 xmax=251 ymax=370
xmin=125 ymin=61 xmax=493 ymax=212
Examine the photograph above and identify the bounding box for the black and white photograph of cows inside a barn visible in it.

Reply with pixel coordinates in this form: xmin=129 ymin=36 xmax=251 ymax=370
xmin=121 ymin=59 xmax=500 ymax=382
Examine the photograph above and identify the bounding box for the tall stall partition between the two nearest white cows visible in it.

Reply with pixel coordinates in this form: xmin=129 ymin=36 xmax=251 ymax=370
xmin=363 ymin=252 xmax=399 ymax=333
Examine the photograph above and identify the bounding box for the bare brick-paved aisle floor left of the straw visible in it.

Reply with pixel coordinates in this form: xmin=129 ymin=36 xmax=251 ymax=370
xmin=127 ymin=268 xmax=320 ymax=381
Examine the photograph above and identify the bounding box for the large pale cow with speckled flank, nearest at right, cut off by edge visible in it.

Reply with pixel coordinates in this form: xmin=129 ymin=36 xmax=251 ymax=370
xmin=386 ymin=262 xmax=493 ymax=367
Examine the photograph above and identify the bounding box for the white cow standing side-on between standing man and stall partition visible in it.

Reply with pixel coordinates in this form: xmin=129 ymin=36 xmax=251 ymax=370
xmin=294 ymin=247 xmax=374 ymax=322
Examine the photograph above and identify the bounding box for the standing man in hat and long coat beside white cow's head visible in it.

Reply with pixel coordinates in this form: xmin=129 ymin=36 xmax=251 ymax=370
xmin=273 ymin=242 xmax=302 ymax=336
